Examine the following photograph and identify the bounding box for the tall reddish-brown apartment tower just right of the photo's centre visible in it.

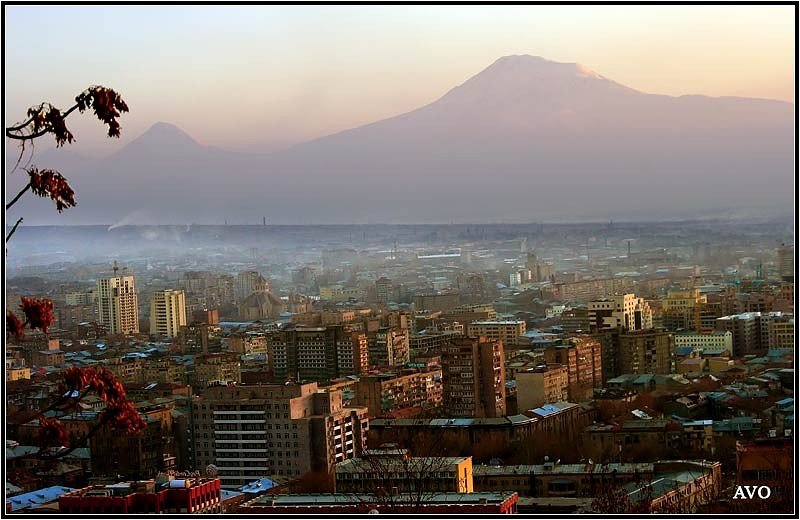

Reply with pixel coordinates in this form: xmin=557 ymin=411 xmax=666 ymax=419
xmin=441 ymin=336 xmax=506 ymax=417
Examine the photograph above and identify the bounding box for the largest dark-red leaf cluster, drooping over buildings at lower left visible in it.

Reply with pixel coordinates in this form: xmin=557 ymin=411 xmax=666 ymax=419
xmin=64 ymin=367 xmax=146 ymax=434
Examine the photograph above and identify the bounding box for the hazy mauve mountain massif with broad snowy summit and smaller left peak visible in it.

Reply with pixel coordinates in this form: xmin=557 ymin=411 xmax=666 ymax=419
xmin=7 ymin=56 xmax=794 ymax=223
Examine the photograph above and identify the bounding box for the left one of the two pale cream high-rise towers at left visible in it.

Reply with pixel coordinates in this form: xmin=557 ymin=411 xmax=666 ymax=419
xmin=97 ymin=275 xmax=139 ymax=334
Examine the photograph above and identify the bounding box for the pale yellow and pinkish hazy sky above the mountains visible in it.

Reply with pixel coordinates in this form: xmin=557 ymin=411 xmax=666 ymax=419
xmin=4 ymin=5 xmax=794 ymax=155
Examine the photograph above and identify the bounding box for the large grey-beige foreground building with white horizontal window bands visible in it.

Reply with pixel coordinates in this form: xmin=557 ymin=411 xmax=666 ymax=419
xmin=192 ymin=383 xmax=369 ymax=488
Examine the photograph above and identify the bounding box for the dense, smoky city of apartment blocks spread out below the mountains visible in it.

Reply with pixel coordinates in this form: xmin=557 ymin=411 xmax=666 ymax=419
xmin=5 ymin=219 xmax=794 ymax=514
